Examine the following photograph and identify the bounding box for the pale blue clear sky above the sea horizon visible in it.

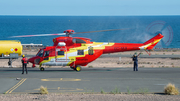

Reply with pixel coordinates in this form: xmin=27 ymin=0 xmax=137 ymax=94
xmin=0 ymin=0 xmax=180 ymax=16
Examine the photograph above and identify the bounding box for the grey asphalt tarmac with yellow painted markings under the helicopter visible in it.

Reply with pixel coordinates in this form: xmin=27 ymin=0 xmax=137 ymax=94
xmin=0 ymin=67 xmax=180 ymax=94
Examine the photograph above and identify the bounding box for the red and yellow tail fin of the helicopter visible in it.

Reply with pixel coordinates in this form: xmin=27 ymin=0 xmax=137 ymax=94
xmin=140 ymin=33 xmax=164 ymax=50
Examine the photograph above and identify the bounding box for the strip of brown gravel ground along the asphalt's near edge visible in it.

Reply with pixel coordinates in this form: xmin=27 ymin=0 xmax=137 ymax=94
xmin=0 ymin=94 xmax=180 ymax=101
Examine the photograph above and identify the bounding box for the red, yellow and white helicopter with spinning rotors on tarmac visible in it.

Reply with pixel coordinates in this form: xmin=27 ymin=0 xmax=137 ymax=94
xmin=11 ymin=29 xmax=164 ymax=72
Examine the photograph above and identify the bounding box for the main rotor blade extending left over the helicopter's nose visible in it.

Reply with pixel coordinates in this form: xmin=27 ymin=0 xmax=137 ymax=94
xmin=10 ymin=33 xmax=66 ymax=38
